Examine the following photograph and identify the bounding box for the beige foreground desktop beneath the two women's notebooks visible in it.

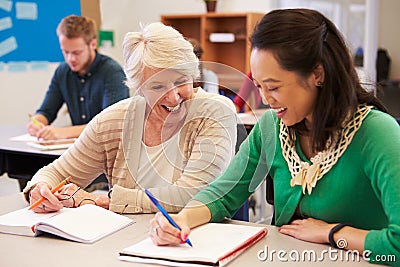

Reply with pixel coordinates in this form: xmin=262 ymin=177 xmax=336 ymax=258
xmin=0 ymin=194 xmax=372 ymax=267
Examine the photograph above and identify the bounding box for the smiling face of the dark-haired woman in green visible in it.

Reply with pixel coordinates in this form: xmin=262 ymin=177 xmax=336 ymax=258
xmin=250 ymin=49 xmax=323 ymax=126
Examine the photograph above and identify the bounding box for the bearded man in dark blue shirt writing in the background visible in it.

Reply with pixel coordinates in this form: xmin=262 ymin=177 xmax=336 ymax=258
xmin=27 ymin=15 xmax=129 ymax=139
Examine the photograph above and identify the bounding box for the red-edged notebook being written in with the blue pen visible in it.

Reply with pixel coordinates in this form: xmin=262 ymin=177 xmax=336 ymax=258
xmin=119 ymin=223 xmax=267 ymax=266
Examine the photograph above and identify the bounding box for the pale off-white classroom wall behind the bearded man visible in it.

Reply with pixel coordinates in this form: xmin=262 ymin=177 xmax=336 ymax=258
xmin=0 ymin=0 xmax=270 ymax=126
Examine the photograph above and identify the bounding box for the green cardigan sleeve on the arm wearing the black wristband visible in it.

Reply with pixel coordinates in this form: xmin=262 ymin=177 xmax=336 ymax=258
xmin=360 ymin=111 xmax=400 ymax=266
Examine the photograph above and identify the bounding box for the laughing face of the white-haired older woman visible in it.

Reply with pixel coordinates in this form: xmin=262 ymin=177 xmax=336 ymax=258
xmin=140 ymin=68 xmax=193 ymax=122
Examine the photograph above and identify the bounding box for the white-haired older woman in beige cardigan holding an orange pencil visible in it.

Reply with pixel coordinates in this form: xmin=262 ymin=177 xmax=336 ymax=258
xmin=24 ymin=23 xmax=236 ymax=216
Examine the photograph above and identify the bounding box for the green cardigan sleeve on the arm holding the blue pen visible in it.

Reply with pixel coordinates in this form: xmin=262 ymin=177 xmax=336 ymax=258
xmin=194 ymin=111 xmax=276 ymax=222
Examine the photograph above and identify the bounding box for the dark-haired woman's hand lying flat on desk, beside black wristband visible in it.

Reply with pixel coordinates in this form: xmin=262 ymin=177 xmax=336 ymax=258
xmin=279 ymin=218 xmax=335 ymax=243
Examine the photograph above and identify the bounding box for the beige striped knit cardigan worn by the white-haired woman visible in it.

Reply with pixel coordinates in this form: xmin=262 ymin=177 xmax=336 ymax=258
xmin=24 ymin=88 xmax=237 ymax=213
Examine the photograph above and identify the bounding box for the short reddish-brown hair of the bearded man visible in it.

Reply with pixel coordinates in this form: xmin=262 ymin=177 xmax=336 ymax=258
xmin=57 ymin=15 xmax=97 ymax=44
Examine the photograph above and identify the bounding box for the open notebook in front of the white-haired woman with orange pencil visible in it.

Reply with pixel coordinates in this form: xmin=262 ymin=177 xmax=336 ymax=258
xmin=0 ymin=204 xmax=133 ymax=243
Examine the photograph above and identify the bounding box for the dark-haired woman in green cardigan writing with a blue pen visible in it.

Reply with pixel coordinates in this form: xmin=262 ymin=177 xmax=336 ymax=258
xmin=150 ymin=9 xmax=400 ymax=266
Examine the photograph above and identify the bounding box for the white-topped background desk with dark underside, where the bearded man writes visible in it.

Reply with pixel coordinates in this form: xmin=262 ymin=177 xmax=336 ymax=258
xmin=0 ymin=125 xmax=65 ymax=189
